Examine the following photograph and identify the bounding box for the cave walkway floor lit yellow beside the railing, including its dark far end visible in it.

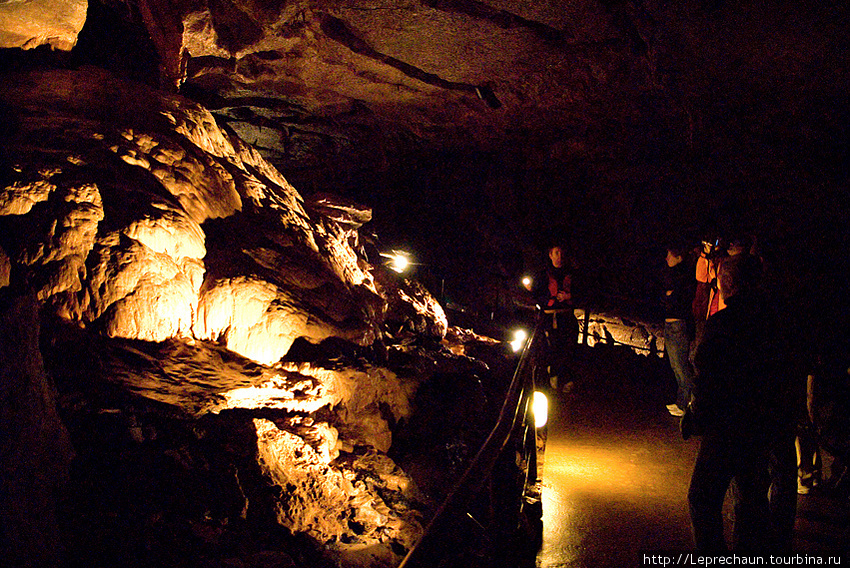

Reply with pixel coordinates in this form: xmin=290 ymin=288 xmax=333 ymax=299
xmin=536 ymin=347 xmax=850 ymax=568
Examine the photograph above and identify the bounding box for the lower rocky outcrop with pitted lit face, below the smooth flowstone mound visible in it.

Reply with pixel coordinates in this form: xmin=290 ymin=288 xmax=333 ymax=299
xmin=37 ymin=312 xmax=434 ymax=567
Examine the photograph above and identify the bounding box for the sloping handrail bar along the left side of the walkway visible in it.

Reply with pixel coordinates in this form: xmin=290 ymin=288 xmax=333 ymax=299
xmin=398 ymin=317 xmax=543 ymax=568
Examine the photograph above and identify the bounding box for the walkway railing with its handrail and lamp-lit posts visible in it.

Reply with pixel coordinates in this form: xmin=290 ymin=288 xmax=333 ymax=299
xmin=398 ymin=310 xmax=544 ymax=568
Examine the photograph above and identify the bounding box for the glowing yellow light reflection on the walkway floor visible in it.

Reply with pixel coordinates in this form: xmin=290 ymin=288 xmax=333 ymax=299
xmin=537 ymin=390 xmax=696 ymax=568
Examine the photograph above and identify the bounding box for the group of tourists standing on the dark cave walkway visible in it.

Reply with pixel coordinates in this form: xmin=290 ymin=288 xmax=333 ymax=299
xmin=533 ymin=234 xmax=828 ymax=552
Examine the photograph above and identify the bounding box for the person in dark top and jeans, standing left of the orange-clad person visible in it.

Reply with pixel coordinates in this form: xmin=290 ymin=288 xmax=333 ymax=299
xmin=661 ymin=244 xmax=695 ymax=416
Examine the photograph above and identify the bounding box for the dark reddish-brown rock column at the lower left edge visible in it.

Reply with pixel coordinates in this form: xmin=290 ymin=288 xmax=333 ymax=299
xmin=0 ymin=289 xmax=74 ymax=567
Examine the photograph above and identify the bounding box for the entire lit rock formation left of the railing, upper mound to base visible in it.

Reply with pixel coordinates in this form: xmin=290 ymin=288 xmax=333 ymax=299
xmin=0 ymin=68 xmax=486 ymax=567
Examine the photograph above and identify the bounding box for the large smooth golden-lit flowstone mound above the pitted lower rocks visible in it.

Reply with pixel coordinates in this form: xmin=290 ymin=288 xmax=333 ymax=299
xmin=0 ymin=69 xmax=388 ymax=363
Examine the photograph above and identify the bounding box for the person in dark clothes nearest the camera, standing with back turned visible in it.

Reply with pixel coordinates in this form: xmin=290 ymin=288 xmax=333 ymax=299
xmin=688 ymin=256 xmax=793 ymax=552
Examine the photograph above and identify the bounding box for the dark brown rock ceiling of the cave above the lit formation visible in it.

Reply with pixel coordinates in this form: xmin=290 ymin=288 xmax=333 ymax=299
xmin=1 ymin=0 xmax=850 ymax=310
